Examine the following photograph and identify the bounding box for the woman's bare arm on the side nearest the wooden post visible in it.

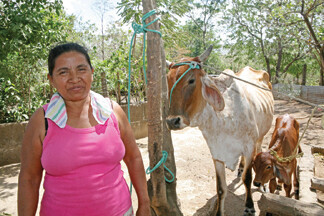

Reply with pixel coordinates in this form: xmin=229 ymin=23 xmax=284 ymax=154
xmin=113 ymin=103 xmax=150 ymax=216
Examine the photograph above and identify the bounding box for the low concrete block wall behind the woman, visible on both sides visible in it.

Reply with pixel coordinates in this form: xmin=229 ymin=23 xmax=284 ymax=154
xmin=0 ymin=103 xmax=147 ymax=166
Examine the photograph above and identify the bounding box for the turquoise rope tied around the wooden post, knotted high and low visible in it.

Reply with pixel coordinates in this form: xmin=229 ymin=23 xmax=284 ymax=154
xmin=127 ymin=10 xmax=174 ymax=189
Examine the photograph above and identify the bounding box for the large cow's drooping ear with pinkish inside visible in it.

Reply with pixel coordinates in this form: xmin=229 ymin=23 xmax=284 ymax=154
xmin=201 ymin=76 xmax=225 ymax=111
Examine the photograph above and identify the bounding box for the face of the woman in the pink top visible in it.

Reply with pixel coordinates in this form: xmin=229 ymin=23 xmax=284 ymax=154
xmin=48 ymin=51 xmax=93 ymax=101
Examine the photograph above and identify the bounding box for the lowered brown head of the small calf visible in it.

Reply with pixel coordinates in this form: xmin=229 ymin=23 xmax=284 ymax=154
xmin=252 ymin=151 xmax=291 ymax=187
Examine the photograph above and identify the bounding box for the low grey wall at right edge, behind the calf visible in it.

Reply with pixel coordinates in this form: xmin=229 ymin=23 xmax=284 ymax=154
xmin=273 ymin=84 xmax=324 ymax=104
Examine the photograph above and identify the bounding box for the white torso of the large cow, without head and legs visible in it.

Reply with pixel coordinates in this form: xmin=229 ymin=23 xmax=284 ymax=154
xmin=199 ymin=67 xmax=274 ymax=170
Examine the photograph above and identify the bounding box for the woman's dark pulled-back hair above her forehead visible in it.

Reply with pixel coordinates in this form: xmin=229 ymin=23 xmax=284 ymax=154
xmin=48 ymin=43 xmax=92 ymax=76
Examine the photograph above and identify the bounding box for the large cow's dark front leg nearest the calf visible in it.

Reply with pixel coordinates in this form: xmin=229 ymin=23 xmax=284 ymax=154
xmin=242 ymin=158 xmax=255 ymax=215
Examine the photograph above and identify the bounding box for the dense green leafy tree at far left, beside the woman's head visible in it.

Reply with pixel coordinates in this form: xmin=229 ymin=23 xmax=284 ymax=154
xmin=0 ymin=0 xmax=71 ymax=120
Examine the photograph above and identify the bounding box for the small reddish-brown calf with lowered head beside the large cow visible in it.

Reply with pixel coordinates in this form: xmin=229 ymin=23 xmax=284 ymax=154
xmin=253 ymin=114 xmax=302 ymax=199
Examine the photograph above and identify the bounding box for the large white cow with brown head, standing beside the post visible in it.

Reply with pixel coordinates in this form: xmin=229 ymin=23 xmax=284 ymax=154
xmin=167 ymin=47 xmax=274 ymax=215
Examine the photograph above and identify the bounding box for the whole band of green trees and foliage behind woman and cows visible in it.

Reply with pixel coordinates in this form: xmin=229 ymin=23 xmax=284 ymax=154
xmin=0 ymin=0 xmax=324 ymax=122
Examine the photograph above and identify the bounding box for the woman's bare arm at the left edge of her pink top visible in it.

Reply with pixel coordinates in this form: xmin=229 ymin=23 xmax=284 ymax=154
xmin=18 ymin=108 xmax=45 ymax=216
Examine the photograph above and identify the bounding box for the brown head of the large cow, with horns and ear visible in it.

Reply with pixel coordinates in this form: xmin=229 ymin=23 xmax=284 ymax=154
xmin=167 ymin=46 xmax=224 ymax=130
